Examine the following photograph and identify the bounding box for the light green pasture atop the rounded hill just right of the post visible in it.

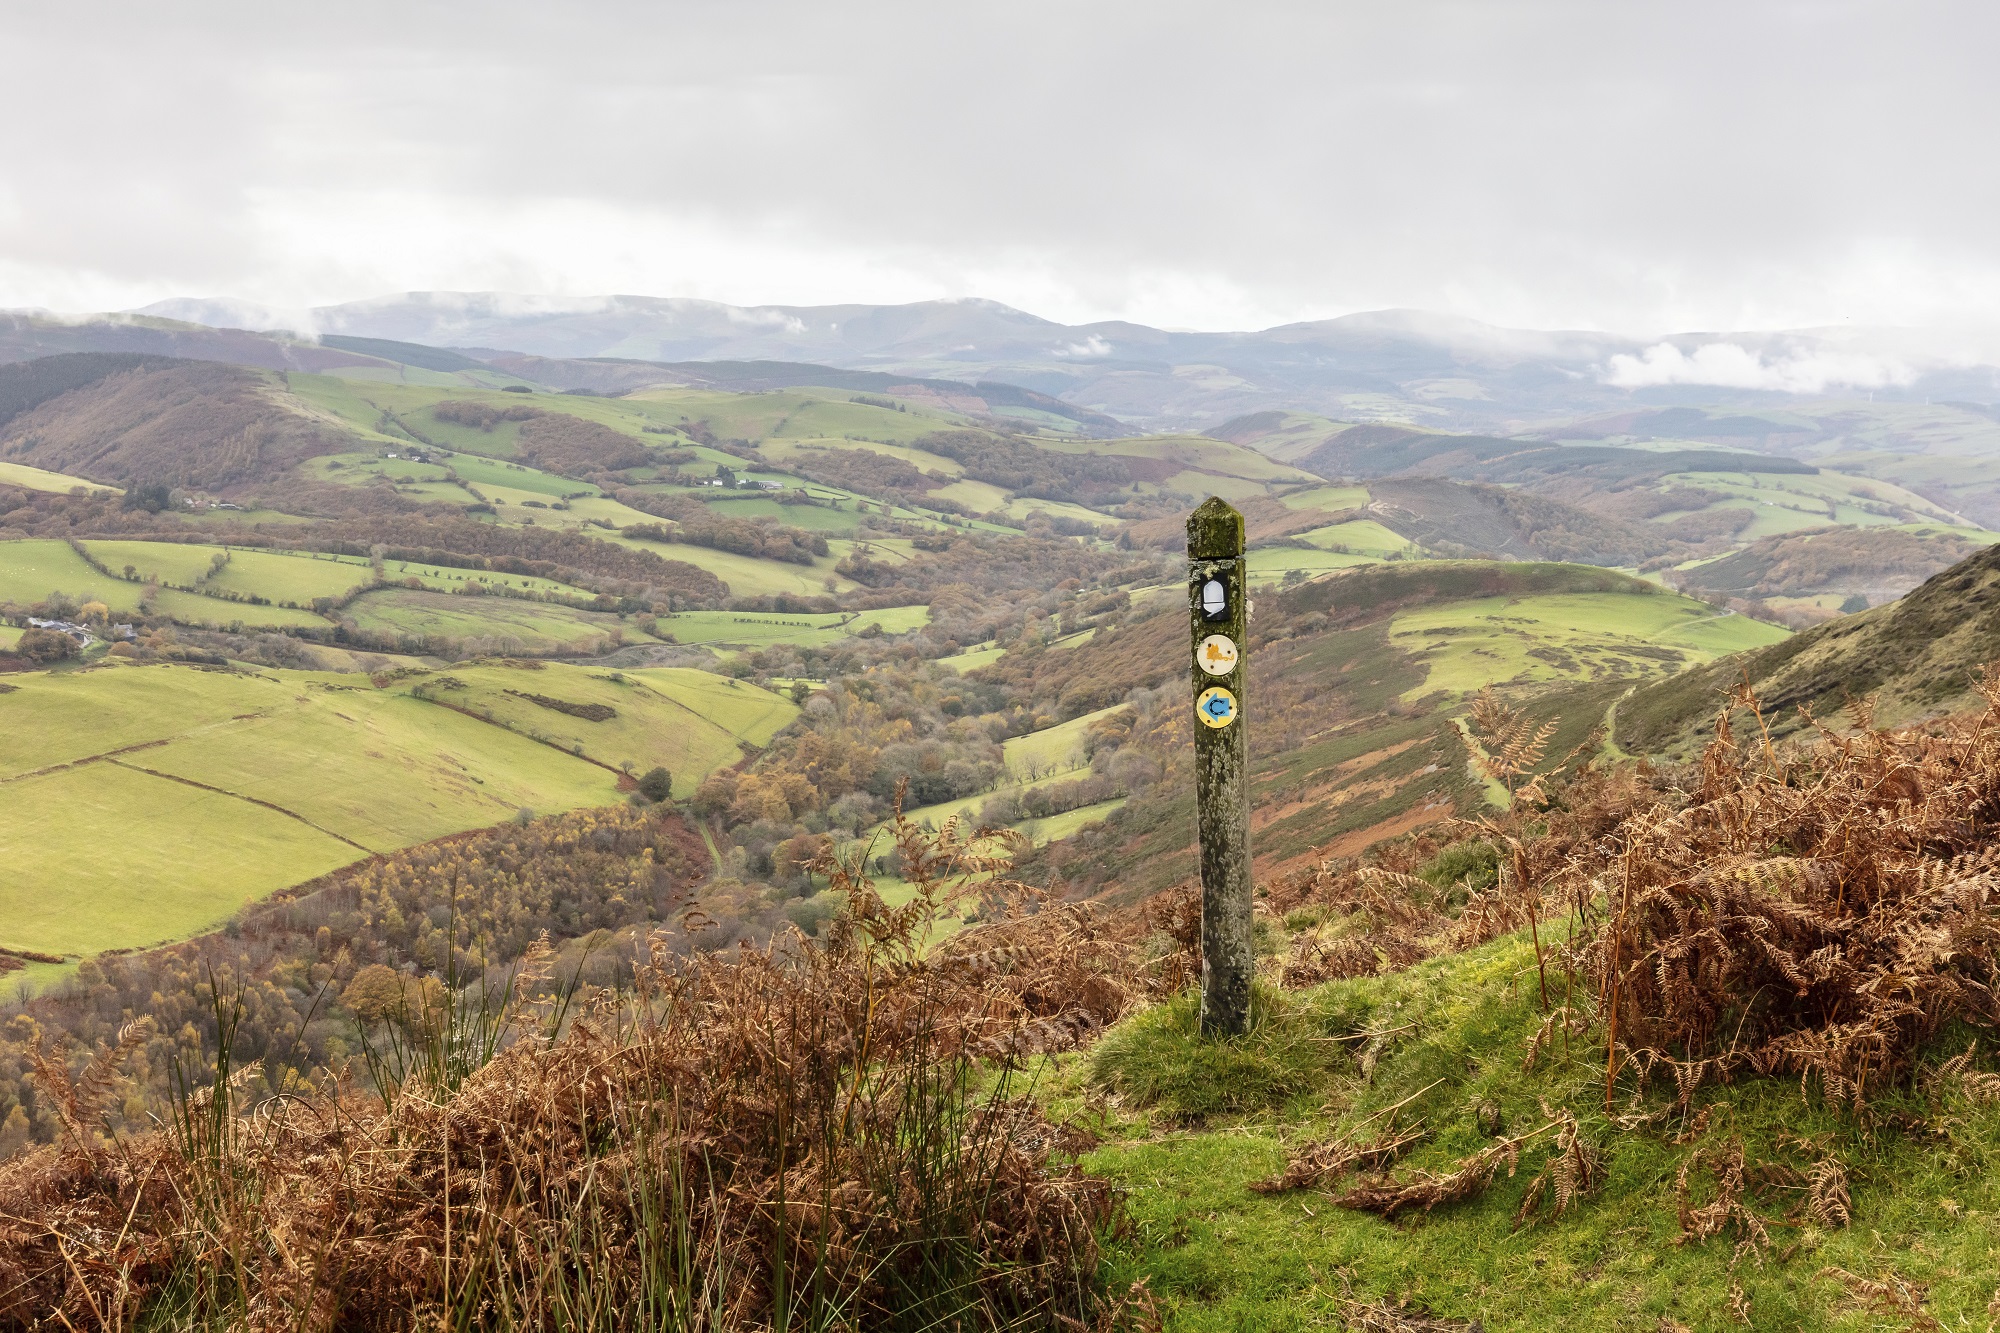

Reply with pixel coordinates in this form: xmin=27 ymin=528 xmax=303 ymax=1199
xmin=1390 ymin=592 xmax=1786 ymax=699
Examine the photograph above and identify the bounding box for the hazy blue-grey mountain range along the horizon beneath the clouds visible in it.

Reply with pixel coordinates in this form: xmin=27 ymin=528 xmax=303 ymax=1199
xmin=138 ymin=292 xmax=2000 ymax=434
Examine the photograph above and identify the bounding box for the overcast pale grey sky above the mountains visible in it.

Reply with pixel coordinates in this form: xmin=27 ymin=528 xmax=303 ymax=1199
xmin=0 ymin=0 xmax=2000 ymax=334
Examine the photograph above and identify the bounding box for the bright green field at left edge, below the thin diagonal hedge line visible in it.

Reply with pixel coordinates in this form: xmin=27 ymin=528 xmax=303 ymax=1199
xmin=0 ymin=752 xmax=362 ymax=955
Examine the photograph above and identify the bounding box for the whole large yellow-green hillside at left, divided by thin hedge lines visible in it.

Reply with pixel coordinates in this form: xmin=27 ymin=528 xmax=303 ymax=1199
xmin=0 ymin=664 xmax=798 ymax=964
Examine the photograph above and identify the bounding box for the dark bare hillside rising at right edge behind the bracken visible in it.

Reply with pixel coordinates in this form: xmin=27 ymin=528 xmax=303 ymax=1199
xmin=1618 ymin=546 xmax=2000 ymax=755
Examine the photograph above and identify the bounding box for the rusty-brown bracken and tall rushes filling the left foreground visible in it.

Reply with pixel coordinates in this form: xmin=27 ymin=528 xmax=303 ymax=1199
xmin=0 ymin=823 xmax=1128 ymax=1331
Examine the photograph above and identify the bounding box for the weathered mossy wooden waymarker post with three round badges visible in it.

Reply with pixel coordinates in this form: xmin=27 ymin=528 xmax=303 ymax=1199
xmin=1188 ymin=496 xmax=1256 ymax=1037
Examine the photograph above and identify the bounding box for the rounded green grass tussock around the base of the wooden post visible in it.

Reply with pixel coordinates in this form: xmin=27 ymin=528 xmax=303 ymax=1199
xmin=1090 ymin=987 xmax=1352 ymax=1123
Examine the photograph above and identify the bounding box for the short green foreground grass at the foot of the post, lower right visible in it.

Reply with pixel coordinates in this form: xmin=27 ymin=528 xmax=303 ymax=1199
xmin=1062 ymin=920 xmax=2000 ymax=1333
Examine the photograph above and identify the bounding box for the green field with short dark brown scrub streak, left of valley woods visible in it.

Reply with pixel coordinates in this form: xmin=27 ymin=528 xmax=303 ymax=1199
xmin=416 ymin=662 xmax=798 ymax=797
